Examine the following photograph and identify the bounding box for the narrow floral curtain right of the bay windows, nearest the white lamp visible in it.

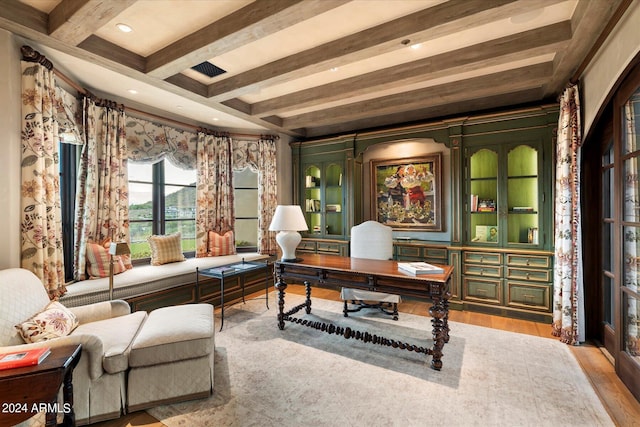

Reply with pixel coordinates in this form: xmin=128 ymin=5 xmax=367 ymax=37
xmin=258 ymin=136 xmax=278 ymax=254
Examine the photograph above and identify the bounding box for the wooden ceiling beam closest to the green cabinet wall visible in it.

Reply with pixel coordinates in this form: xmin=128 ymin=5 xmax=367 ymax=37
xmin=283 ymin=62 xmax=553 ymax=129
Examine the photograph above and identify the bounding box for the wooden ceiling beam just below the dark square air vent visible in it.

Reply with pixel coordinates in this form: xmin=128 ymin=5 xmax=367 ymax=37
xmin=209 ymin=0 xmax=560 ymax=101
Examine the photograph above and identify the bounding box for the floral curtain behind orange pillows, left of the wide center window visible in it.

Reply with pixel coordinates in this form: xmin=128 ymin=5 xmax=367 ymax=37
xmin=74 ymin=97 xmax=131 ymax=280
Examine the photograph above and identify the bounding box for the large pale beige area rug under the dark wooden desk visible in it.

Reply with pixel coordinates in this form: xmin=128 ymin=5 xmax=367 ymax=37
xmin=147 ymin=293 xmax=614 ymax=427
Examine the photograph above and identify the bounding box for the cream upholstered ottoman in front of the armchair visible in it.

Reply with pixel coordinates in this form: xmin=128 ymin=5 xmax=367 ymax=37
xmin=127 ymin=304 xmax=215 ymax=412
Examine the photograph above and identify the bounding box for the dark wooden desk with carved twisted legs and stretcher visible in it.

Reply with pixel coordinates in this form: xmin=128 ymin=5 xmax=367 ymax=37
xmin=274 ymin=254 xmax=453 ymax=370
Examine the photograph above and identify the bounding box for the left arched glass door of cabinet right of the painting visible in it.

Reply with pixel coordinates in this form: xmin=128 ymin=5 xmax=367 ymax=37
xmin=468 ymin=148 xmax=500 ymax=244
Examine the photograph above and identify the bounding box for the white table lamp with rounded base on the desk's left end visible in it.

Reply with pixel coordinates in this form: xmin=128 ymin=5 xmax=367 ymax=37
xmin=269 ymin=205 xmax=309 ymax=262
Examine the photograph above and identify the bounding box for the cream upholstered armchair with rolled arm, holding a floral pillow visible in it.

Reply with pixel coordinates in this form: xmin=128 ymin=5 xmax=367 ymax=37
xmin=0 ymin=268 xmax=147 ymax=425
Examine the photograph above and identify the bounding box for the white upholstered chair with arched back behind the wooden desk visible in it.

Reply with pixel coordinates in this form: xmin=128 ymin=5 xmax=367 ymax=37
xmin=340 ymin=221 xmax=400 ymax=320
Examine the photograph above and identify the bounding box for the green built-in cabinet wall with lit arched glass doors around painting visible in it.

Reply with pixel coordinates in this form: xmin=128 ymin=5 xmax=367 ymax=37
xmin=291 ymin=105 xmax=558 ymax=322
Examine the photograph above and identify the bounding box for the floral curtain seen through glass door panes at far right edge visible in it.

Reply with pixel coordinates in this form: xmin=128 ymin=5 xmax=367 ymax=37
xmin=621 ymin=98 xmax=640 ymax=357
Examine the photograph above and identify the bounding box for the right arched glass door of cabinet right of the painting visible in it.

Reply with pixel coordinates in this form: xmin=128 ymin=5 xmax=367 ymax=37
xmin=505 ymin=145 xmax=540 ymax=246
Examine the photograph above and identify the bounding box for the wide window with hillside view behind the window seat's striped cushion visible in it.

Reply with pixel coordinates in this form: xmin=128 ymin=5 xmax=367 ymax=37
xmin=128 ymin=160 xmax=196 ymax=260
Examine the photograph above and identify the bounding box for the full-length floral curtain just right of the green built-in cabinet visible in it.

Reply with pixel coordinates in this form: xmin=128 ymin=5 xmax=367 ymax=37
xmin=552 ymin=85 xmax=584 ymax=345
